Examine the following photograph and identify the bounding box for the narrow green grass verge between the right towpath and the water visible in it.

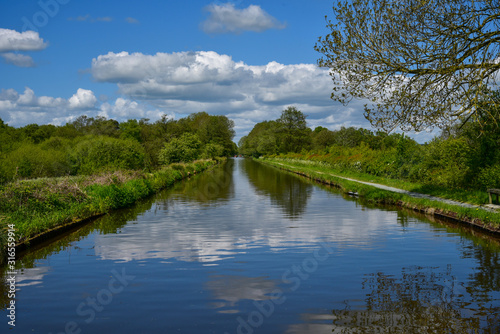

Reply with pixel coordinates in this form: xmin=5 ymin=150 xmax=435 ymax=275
xmin=255 ymin=157 xmax=500 ymax=234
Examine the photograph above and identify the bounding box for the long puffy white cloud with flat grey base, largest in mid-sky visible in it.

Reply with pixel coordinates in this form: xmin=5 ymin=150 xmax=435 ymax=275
xmin=91 ymin=51 xmax=331 ymax=105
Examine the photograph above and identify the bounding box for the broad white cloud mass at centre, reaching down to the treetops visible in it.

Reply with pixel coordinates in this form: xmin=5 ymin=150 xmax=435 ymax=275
xmin=91 ymin=51 xmax=369 ymax=140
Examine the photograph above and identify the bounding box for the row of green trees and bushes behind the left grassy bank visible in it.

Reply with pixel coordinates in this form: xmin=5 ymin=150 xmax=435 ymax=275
xmin=0 ymin=112 xmax=237 ymax=183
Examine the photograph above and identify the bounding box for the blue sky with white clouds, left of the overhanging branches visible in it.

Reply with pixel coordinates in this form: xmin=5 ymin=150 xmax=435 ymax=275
xmin=0 ymin=0 xmax=431 ymax=141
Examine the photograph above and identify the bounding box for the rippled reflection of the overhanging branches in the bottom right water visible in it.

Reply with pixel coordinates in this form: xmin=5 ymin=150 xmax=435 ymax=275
xmin=332 ymin=266 xmax=500 ymax=333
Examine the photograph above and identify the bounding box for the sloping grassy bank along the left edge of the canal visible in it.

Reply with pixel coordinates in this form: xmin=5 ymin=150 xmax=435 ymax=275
xmin=0 ymin=160 xmax=219 ymax=259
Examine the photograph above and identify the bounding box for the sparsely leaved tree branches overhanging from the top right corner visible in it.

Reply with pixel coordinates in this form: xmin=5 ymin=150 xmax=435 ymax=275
xmin=315 ymin=0 xmax=500 ymax=131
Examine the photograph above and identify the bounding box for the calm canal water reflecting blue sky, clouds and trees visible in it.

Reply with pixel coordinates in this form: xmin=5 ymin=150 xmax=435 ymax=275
xmin=0 ymin=159 xmax=500 ymax=334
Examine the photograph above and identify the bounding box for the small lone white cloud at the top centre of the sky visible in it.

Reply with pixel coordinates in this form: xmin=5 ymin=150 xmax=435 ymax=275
xmin=201 ymin=3 xmax=285 ymax=34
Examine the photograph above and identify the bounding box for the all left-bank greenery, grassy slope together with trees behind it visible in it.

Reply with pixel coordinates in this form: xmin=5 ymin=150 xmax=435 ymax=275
xmin=0 ymin=112 xmax=237 ymax=263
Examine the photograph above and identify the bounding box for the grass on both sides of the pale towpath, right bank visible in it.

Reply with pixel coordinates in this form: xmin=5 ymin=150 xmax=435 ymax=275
xmin=258 ymin=158 xmax=500 ymax=232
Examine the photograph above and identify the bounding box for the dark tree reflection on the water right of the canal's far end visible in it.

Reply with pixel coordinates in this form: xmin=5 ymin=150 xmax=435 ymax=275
xmin=240 ymin=159 xmax=313 ymax=219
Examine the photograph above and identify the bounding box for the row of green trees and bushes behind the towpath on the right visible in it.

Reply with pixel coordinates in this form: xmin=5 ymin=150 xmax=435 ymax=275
xmin=239 ymin=104 xmax=500 ymax=190
